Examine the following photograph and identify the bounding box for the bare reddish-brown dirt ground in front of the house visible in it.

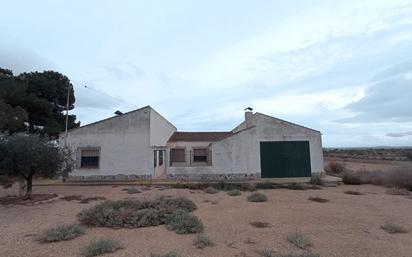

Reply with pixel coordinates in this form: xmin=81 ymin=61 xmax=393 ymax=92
xmin=0 ymin=182 xmax=412 ymax=257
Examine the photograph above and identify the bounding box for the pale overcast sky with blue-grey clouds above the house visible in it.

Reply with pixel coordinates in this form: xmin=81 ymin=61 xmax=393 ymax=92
xmin=0 ymin=0 xmax=412 ymax=146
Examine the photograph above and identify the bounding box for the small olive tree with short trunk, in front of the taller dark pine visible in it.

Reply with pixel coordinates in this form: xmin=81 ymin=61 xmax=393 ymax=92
xmin=0 ymin=135 xmax=73 ymax=198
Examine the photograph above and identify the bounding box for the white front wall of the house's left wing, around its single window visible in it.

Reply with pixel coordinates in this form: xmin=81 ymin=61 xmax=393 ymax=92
xmin=63 ymin=107 xmax=154 ymax=178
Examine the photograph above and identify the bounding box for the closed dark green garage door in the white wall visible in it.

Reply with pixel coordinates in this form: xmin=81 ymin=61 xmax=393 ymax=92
xmin=260 ymin=141 xmax=311 ymax=178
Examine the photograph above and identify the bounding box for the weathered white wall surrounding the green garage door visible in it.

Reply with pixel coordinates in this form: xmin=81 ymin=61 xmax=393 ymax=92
xmin=168 ymin=113 xmax=324 ymax=179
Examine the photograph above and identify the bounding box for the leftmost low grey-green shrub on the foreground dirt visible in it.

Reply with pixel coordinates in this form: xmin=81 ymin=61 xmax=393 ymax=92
xmin=37 ymin=224 xmax=85 ymax=243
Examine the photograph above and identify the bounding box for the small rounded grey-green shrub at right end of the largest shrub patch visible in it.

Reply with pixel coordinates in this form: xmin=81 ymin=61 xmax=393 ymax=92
xmin=165 ymin=209 xmax=203 ymax=234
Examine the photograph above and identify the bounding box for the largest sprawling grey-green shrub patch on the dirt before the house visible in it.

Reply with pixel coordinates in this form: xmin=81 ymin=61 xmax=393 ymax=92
xmin=78 ymin=197 xmax=200 ymax=232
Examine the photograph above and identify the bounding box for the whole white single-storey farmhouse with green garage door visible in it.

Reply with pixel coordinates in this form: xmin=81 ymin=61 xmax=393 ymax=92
xmin=61 ymin=106 xmax=323 ymax=180
